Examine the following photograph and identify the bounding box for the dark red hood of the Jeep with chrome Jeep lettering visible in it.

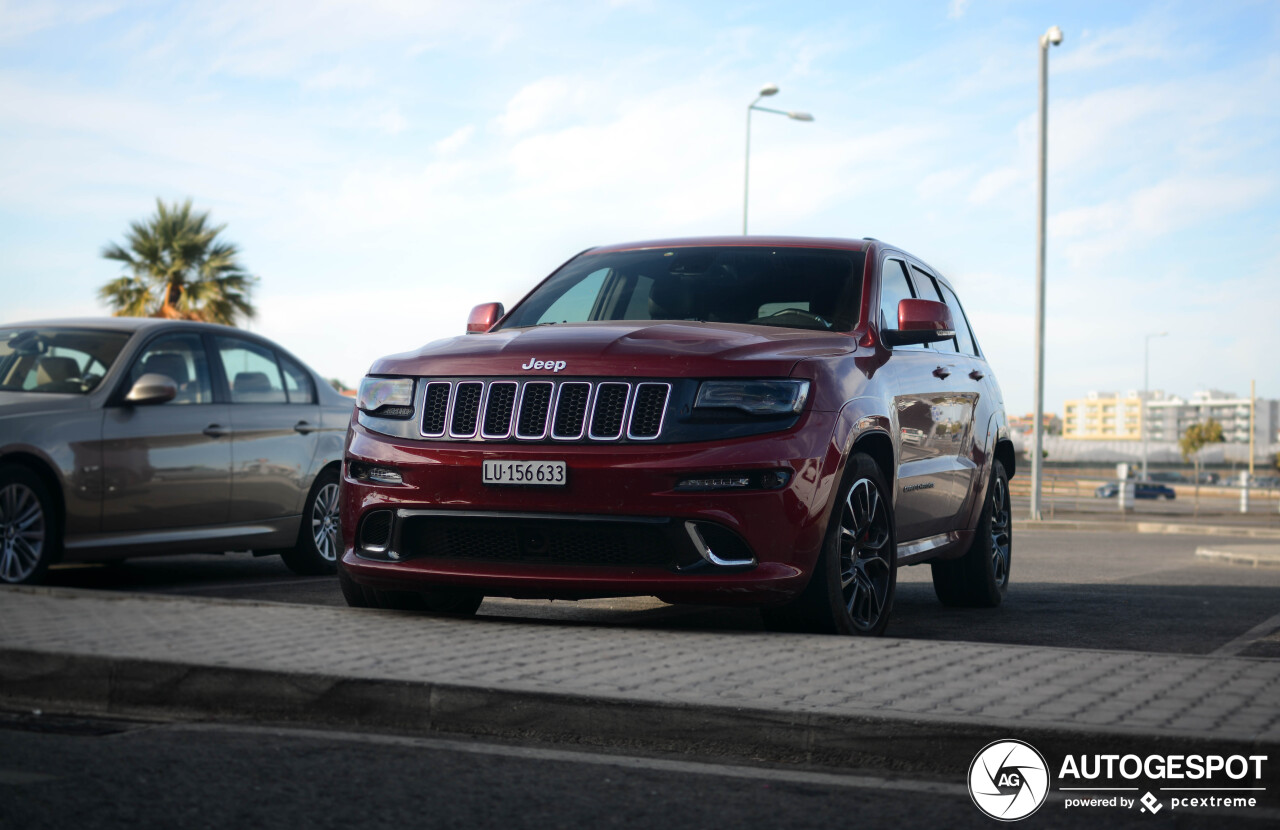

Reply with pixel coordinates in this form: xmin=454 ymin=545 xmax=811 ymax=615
xmin=370 ymin=321 xmax=858 ymax=378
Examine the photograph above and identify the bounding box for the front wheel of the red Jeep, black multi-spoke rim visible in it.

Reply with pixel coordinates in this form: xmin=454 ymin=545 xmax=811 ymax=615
xmin=762 ymin=452 xmax=897 ymax=637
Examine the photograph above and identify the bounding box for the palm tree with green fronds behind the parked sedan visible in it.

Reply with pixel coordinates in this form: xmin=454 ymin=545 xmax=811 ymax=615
xmin=97 ymin=199 xmax=257 ymax=325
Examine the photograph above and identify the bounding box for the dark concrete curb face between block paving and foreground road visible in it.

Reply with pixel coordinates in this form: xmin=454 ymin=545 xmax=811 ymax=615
xmin=0 ymin=648 xmax=1280 ymax=786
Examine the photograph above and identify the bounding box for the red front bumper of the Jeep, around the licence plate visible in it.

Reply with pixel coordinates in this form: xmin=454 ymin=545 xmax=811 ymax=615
xmin=342 ymin=412 xmax=840 ymax=603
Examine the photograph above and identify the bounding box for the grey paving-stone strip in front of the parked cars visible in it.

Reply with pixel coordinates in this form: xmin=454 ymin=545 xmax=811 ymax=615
xmin=0 ymin=588 xmax=1280 ymax=744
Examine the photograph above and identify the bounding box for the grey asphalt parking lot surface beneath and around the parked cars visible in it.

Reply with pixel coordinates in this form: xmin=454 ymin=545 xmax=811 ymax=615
xmin=37 ymin=530 xmax=1280 ymax=657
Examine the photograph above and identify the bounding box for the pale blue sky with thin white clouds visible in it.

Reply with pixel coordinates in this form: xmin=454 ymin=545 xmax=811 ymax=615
xmin=0 ymin=0 xmax=1280 ymax=412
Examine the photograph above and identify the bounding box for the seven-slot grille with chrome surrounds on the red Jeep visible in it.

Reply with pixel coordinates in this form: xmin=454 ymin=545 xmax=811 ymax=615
xmin=420 ymin=379 xmax=671 ymax=441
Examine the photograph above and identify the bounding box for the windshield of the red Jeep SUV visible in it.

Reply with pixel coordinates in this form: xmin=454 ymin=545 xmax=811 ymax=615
xmin=500 ymin=247 xmax=863 ymax=332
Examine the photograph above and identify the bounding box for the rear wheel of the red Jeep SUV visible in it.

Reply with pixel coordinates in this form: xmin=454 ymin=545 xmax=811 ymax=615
xmin=931 ymin=461 xmax=1014 ymax=608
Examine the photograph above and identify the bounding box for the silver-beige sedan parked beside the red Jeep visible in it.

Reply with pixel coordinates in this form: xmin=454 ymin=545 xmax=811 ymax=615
xmin=0 ymin=318 xmax=352 ymax=583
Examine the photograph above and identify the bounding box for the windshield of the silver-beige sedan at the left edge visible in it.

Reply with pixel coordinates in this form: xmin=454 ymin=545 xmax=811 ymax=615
xmin=0 ymin=328 xmax=129 ymax=395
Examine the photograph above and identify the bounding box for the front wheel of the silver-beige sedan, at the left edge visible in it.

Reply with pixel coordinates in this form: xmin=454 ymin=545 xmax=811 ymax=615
xmin=0 ymin=464 xmax=61 ymax=585
